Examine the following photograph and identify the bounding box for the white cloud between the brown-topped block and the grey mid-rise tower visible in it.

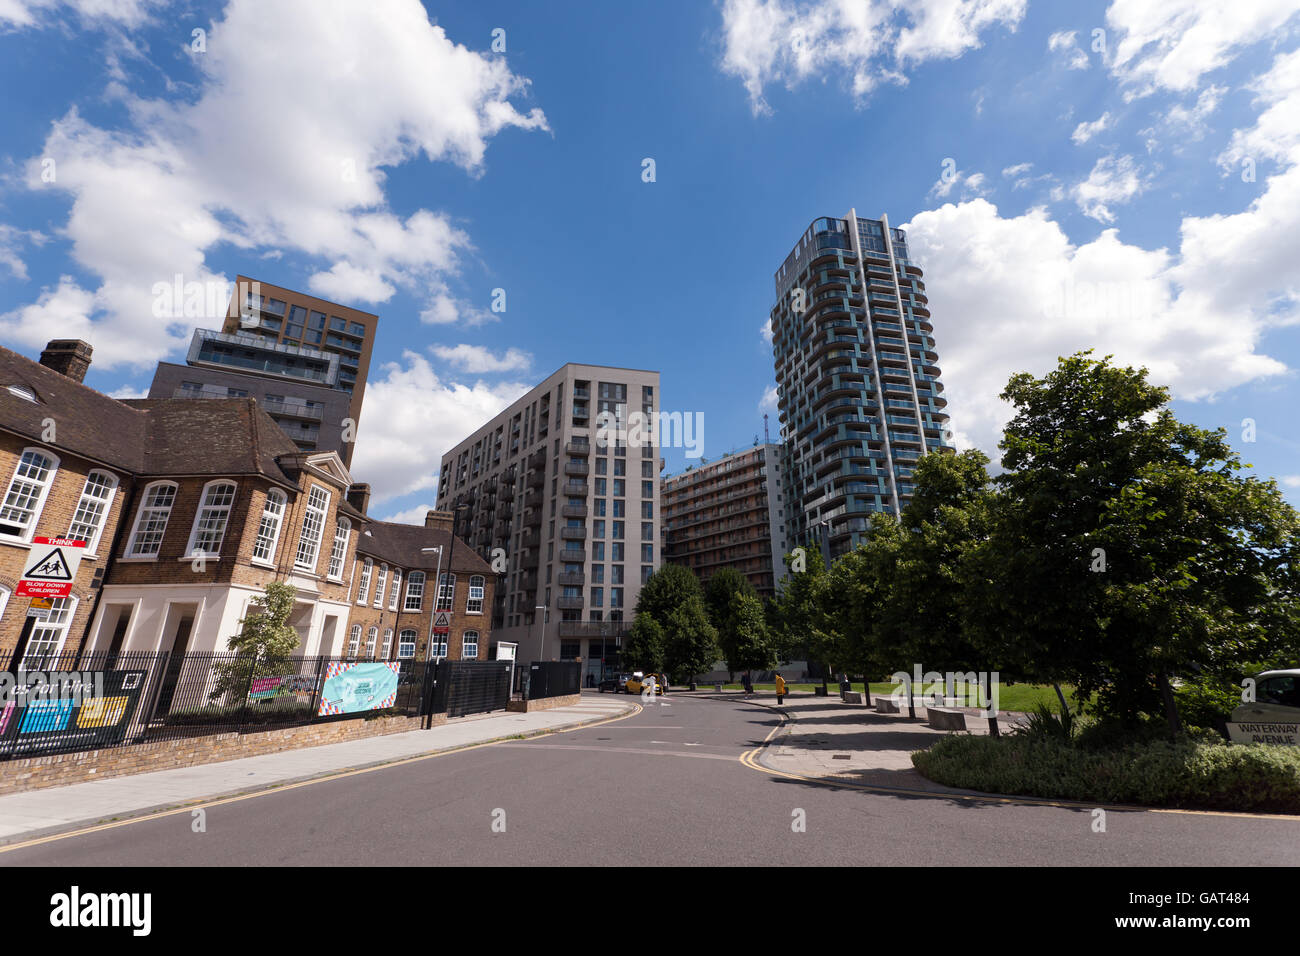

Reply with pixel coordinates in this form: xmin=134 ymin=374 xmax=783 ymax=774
xmin=352 ymin=351 xmax=532 ymax=502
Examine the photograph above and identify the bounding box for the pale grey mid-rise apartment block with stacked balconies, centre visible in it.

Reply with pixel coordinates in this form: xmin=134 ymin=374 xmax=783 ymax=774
xmin=438 ymin=363 xmax=663 ymax=683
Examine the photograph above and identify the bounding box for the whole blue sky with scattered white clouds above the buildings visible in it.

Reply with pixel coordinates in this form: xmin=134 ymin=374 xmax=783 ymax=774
xmin=0 ymin=0 xmax=1300 ymax=515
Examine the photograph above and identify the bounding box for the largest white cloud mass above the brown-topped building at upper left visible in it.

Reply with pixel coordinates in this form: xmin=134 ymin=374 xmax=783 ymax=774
xmin=0 ymin=0 xmax=547 ymax=367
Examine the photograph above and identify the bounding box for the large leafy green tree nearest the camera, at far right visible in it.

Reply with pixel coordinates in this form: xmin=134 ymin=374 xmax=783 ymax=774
xmin=965 ymin=352 xmax=1300 ymax=732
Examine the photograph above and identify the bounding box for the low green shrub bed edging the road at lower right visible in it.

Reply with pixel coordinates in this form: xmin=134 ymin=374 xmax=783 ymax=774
xmin=911 ymin=734 xmax=1300 ymax=810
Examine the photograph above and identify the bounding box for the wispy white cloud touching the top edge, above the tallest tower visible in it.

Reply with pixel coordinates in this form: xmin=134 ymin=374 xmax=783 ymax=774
xmin=722 ymin=0 xmax=1026 ymax=114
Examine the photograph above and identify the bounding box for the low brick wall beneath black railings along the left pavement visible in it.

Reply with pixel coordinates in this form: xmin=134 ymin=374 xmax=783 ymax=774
xmin=0 ymin=714 xmax=447 ymax=795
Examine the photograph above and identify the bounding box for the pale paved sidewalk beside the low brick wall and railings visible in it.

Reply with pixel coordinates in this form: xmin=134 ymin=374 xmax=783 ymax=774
xmin=0 ymin=692 xmax=637 ymax=845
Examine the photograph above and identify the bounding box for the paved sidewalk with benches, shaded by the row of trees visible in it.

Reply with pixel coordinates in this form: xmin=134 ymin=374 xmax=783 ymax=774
xmin=692 ymin=691 xmax=1019 ymax=793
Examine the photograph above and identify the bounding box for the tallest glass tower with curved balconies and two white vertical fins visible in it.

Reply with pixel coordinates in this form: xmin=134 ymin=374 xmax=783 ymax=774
xmin=771 ymin=209 xmax=952 ymax=557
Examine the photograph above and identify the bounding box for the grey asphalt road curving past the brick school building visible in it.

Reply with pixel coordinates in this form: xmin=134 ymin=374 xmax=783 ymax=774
xmin=0 ymin=696 xmax=1300 ymax=866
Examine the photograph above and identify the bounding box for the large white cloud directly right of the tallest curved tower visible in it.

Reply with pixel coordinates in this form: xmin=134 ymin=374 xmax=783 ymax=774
xmin=904 ymin=182 xmax=1300 ymax=457
